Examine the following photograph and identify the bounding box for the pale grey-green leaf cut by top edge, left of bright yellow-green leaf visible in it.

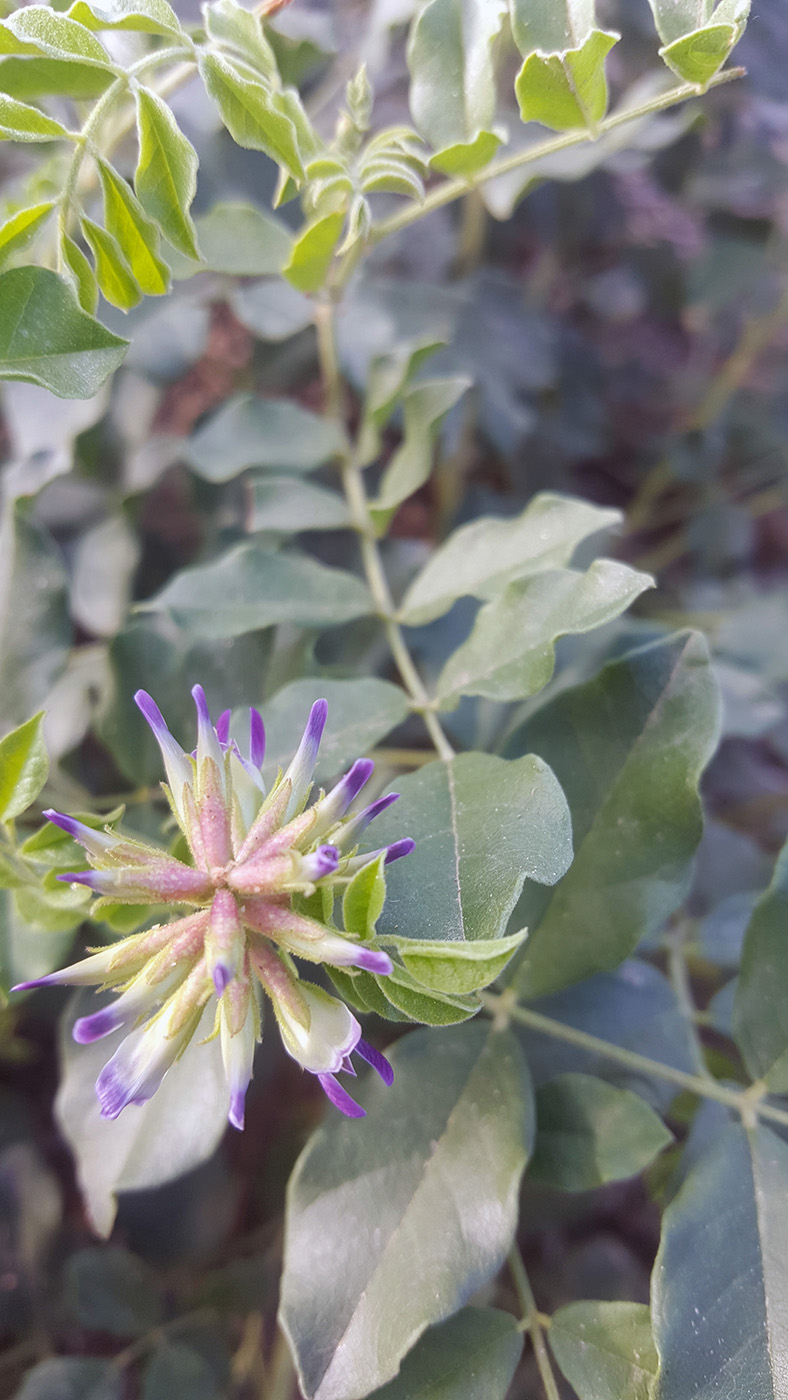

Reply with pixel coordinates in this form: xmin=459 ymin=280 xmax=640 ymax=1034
xmin=407 ymin=0 xmax=505 ymax=150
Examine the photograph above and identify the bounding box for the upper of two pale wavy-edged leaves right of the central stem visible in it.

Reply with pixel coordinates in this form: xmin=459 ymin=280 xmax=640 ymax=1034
xmin=400 ymin=491 xmax=620 ymax=626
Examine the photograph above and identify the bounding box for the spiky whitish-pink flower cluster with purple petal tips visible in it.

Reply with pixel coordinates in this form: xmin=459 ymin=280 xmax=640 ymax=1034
xmin=21 ymin=686 xmax=413 ymax=1128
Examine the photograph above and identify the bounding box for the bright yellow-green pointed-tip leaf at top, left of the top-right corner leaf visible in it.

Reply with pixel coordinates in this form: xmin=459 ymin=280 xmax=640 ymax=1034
xmin=515 ymin=29 xmax=619 ymax=132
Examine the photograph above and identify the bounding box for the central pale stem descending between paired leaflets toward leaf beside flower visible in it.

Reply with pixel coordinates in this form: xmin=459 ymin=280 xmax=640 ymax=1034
xmin=315 ymin=300 xmax=453 ymax=763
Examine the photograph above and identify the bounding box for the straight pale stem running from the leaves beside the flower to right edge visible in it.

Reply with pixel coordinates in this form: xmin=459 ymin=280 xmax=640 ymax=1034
xmin=481 ymin=991 xmax=788 ymax=1126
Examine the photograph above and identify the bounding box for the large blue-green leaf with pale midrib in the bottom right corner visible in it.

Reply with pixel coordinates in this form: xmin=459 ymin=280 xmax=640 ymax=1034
xmin=651 ymin=1124 xmax=788 ymax=1400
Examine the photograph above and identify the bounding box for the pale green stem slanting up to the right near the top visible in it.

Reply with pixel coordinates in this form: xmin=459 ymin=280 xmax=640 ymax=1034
xmin=370 ymin=69 xmax=745 ymax=242
